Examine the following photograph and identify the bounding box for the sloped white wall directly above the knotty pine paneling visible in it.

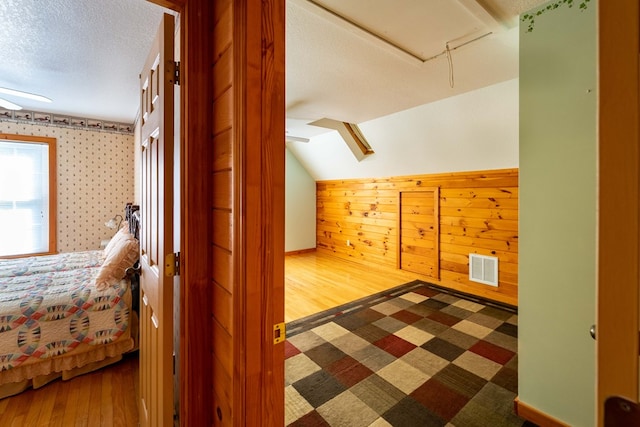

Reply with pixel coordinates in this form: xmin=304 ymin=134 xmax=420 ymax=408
xmin=289 ymin=79 xmax=519 ymax=180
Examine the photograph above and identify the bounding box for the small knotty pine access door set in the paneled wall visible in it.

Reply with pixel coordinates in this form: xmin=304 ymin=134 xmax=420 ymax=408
xmin=398 ymin=187 xmax=440 ymax=279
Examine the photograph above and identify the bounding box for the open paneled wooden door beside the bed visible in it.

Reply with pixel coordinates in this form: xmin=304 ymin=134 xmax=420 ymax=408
xmin=139 ymin=14 xmax=174 ymax=427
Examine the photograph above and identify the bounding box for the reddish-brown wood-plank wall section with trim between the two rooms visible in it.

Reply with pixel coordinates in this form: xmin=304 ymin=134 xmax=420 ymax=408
xmin=156 ymin=0 xmax=285 ymax=426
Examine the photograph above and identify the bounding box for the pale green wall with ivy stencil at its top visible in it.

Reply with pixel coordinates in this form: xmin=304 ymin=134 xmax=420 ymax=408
xmin=518 ymin=1 xmax=598 ymax=427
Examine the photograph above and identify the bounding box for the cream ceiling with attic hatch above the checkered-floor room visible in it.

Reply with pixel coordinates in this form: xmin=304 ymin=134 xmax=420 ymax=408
xmin=286 ymin=0 xmax=544 ymax=137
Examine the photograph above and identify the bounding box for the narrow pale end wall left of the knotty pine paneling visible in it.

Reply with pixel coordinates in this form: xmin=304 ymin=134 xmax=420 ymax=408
xmin=284 ymin=150 xmax=316 ymax=252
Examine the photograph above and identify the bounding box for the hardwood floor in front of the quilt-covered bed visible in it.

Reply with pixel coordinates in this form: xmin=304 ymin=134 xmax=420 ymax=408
xmin=0 ymin=352 xmax=138 ymax=427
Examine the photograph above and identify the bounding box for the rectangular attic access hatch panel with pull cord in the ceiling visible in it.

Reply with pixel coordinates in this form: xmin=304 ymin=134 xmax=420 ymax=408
xmin=306 ymin=0 xmax=499 ymax=62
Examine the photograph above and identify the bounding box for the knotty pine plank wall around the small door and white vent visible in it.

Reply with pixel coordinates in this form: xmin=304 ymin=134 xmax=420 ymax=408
xmin=316 ymin=169 xmax=518 ymax=305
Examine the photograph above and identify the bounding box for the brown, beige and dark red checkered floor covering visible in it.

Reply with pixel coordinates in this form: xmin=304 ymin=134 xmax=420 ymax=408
xmin=285 ymin=282 xmax=533 ymax=427
